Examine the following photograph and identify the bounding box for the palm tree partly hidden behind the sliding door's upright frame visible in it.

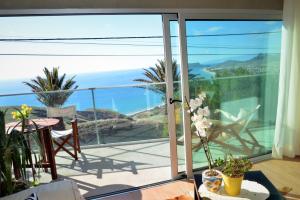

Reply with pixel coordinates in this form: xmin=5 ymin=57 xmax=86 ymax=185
xmin=134 ymin=60 xmax=180 ymax=94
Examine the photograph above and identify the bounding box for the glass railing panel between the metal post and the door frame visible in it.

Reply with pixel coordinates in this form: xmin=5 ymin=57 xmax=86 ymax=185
xmin=95 ymin=83 xmax=169 ymax=145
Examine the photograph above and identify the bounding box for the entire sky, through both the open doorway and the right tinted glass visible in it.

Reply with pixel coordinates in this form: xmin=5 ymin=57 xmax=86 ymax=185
xmin=0 ymin=15 xmax=281 ymax=81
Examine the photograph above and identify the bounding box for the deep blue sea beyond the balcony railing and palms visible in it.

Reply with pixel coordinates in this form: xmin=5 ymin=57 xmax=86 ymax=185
xmin=0 ymin=65 xmax=211 ymax=115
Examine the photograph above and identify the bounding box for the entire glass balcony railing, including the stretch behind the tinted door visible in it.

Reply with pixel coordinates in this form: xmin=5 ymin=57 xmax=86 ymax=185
xmin=0 ymin=74 xmax=278 ymax=151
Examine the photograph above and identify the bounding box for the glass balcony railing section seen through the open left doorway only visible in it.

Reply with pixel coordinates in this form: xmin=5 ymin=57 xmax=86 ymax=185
xmin=0 ymin=83 xmax=168 ymax=146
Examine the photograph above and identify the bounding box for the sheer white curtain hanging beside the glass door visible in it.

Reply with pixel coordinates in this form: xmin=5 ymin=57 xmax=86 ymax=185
xmin=272 ymin=0 xmax=300 ymax=158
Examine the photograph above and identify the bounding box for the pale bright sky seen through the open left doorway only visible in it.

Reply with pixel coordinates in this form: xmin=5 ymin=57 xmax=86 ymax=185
xmin=0 ymin=15 xmax=164 ymax=80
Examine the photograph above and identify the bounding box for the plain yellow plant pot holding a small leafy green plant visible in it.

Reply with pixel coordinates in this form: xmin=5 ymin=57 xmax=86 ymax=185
xmin=222 ymin=174 xmax=244 ymax=196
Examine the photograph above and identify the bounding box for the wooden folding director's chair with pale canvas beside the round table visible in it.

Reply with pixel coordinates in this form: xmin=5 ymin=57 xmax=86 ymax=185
xmin=47 ymin=106 xmax=81 ymax=160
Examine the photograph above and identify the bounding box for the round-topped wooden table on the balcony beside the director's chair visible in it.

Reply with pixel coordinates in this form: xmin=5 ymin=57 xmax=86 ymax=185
xmin=5 ymin=118 xmax=59 ymax=180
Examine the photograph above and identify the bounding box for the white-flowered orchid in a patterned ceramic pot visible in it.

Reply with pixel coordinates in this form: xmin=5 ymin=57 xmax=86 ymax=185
xmin=187 ymin=93 xmax=222 ymax=192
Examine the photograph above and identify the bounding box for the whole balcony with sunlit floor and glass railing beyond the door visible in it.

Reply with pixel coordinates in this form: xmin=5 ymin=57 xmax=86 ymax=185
xmin=0 ymin=74 xmax=276 ymax=197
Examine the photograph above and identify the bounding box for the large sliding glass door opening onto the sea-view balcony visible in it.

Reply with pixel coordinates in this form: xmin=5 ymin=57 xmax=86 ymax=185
xmin=0 ymin=11 xmax=281 ymax=197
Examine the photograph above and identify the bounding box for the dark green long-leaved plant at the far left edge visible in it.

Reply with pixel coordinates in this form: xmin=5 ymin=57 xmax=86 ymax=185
xmin=0 ymin=110 xmax=41 ymax=196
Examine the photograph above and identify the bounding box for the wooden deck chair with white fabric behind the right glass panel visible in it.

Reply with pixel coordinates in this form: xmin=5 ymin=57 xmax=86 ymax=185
xmin=193 ymin=105 xmax=264 ymax=155
